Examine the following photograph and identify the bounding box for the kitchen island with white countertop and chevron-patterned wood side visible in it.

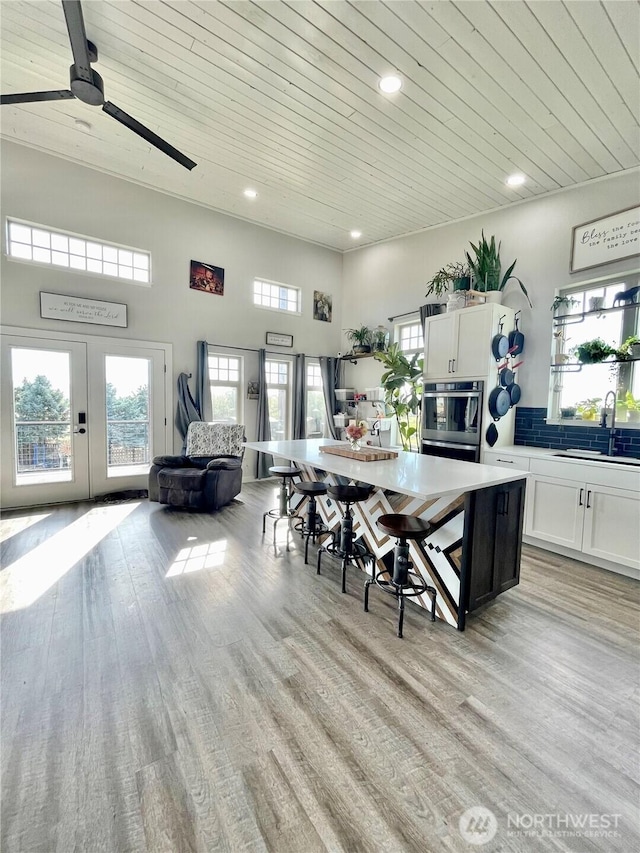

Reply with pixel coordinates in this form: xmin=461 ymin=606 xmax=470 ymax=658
xmin=245 ymin=439 xmax=527 ymax=631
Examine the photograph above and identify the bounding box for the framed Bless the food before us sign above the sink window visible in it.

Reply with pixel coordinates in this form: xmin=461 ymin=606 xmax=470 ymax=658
xmin=570 ymin=207 xmax=640 ymax=272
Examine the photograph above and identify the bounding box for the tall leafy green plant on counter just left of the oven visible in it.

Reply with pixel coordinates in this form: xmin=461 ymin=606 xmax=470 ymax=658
xmin=373 ymin=343 xmax=424 ymax=450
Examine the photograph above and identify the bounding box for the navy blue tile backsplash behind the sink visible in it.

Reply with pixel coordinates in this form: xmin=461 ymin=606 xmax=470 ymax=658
xmin=514 ymin=406 xmax=640 ymax=458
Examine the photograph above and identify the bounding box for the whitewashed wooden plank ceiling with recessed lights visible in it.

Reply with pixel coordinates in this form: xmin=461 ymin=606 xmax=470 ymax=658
xmin=1 ymin=0 xmax=640 ymax=250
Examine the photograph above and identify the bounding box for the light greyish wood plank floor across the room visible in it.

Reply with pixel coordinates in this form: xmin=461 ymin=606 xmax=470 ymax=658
xmin=0 ymin=483 xmax=640 ymax=853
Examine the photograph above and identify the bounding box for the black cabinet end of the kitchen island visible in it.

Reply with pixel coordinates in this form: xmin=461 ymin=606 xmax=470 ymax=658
xmin=461 ymin=480 xmax=526 ymax=612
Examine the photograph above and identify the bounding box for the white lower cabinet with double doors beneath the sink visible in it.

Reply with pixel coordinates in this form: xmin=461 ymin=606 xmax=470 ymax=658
xmin=525 ymin=475 xmax=640 ymax=568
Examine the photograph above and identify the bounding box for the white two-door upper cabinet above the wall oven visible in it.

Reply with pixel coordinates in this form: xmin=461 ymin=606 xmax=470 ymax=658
xmin=424 ymin=304 xmax=513 ymax=380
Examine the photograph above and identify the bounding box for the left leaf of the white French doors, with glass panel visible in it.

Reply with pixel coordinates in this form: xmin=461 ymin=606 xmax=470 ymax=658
xmin=1 ymin=336 xmax=89 ymax=507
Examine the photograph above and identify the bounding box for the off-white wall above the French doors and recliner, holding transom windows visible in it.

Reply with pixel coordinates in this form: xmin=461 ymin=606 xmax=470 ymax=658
xmin=0 ymin=142 xmax=342 ymax=460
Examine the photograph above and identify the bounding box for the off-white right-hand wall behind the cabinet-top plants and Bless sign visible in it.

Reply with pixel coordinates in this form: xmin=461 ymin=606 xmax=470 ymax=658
xmin=341 ymin=170 xmax=640 ymax=406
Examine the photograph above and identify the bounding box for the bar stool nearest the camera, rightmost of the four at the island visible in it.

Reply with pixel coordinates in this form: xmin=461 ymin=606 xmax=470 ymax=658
xmin=364 ymin=514 xmax=437 ymax=637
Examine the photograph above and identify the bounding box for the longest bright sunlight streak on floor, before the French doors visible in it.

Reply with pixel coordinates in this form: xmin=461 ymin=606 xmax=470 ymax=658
xmin=0 ymin=501 xmax=140 ymax=613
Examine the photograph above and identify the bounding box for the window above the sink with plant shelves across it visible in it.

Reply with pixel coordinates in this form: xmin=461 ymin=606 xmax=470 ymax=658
xmin=549 ymin=274 xmax=640 ymax=428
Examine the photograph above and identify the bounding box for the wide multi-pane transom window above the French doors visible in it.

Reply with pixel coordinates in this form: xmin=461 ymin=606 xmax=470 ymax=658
xmin=7 ymin=219 xmax=151 ymax=284
